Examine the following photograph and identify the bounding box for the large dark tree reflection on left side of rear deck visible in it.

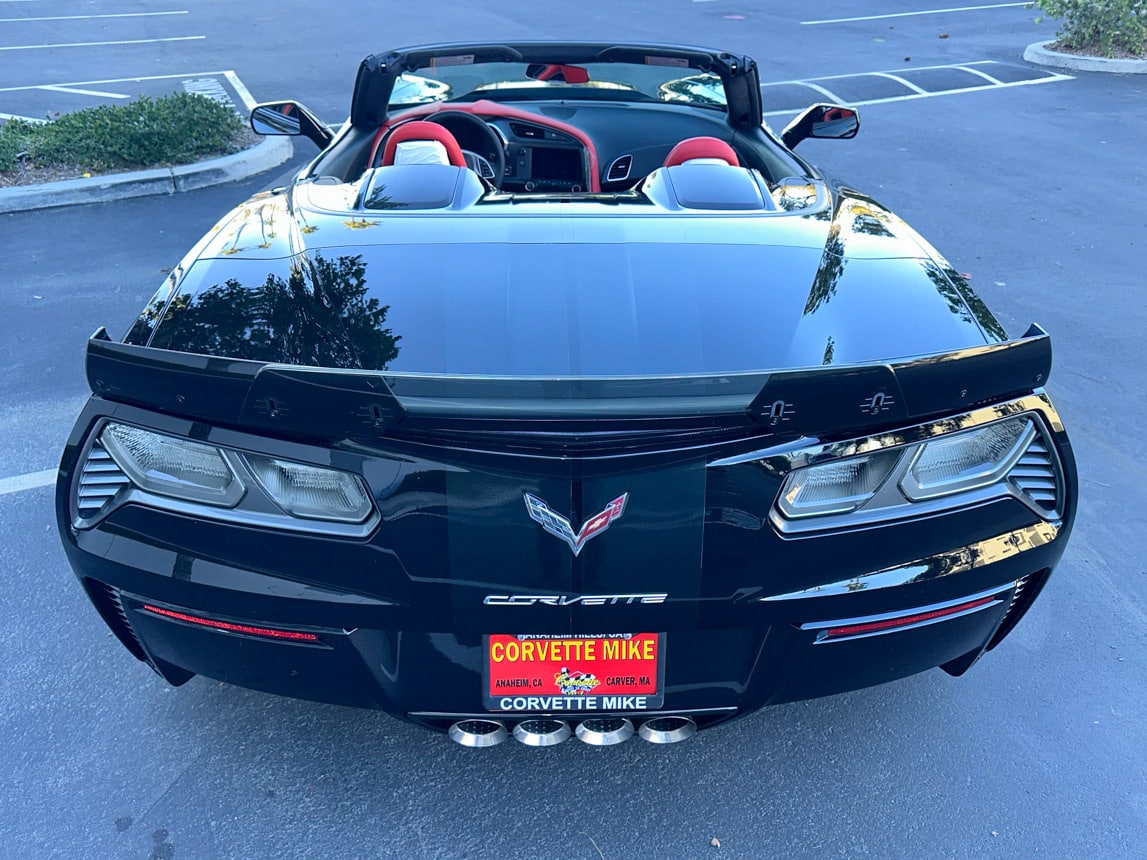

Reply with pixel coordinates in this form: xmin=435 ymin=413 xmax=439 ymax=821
xmin=151 ymin=255 xmax=401 ymax=370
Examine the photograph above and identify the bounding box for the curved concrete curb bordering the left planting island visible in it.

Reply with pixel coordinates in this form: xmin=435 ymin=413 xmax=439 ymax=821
xmin=0 ymin=136 xmax=294 ymax=213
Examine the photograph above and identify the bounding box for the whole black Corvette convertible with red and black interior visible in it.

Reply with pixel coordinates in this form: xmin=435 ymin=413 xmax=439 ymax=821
xmin=56 ymin=44 xmax=1076 ymax=746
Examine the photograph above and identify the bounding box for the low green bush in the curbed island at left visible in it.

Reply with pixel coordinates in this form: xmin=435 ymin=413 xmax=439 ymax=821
xmin=0 ymin=93 xmax=245 ymax=171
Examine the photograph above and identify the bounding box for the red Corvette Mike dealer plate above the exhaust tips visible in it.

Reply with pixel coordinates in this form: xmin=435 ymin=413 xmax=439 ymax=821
xmin=484 ymin=633 xmax=665 ymax=712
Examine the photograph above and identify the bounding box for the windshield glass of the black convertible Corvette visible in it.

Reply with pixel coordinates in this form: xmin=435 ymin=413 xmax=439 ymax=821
xmin=390 ymin=55 xmax=726 ymax=110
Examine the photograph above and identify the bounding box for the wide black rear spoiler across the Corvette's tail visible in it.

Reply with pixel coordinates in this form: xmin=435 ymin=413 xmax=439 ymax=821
xmin=86 ymin=325 xmax=1052 ymax=440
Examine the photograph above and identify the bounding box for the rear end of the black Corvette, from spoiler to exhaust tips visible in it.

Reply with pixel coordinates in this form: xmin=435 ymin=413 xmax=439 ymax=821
xmin=57 ymin=333 xmax=1076 ymax=745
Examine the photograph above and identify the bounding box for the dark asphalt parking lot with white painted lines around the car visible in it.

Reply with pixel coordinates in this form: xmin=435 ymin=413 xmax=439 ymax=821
xmin=0 ymin=0 xmax=1147 ymax=860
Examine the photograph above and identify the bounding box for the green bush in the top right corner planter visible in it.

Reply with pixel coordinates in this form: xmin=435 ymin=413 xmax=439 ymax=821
xmin=1036 ymin=0 xmax=1147 ymax=57
